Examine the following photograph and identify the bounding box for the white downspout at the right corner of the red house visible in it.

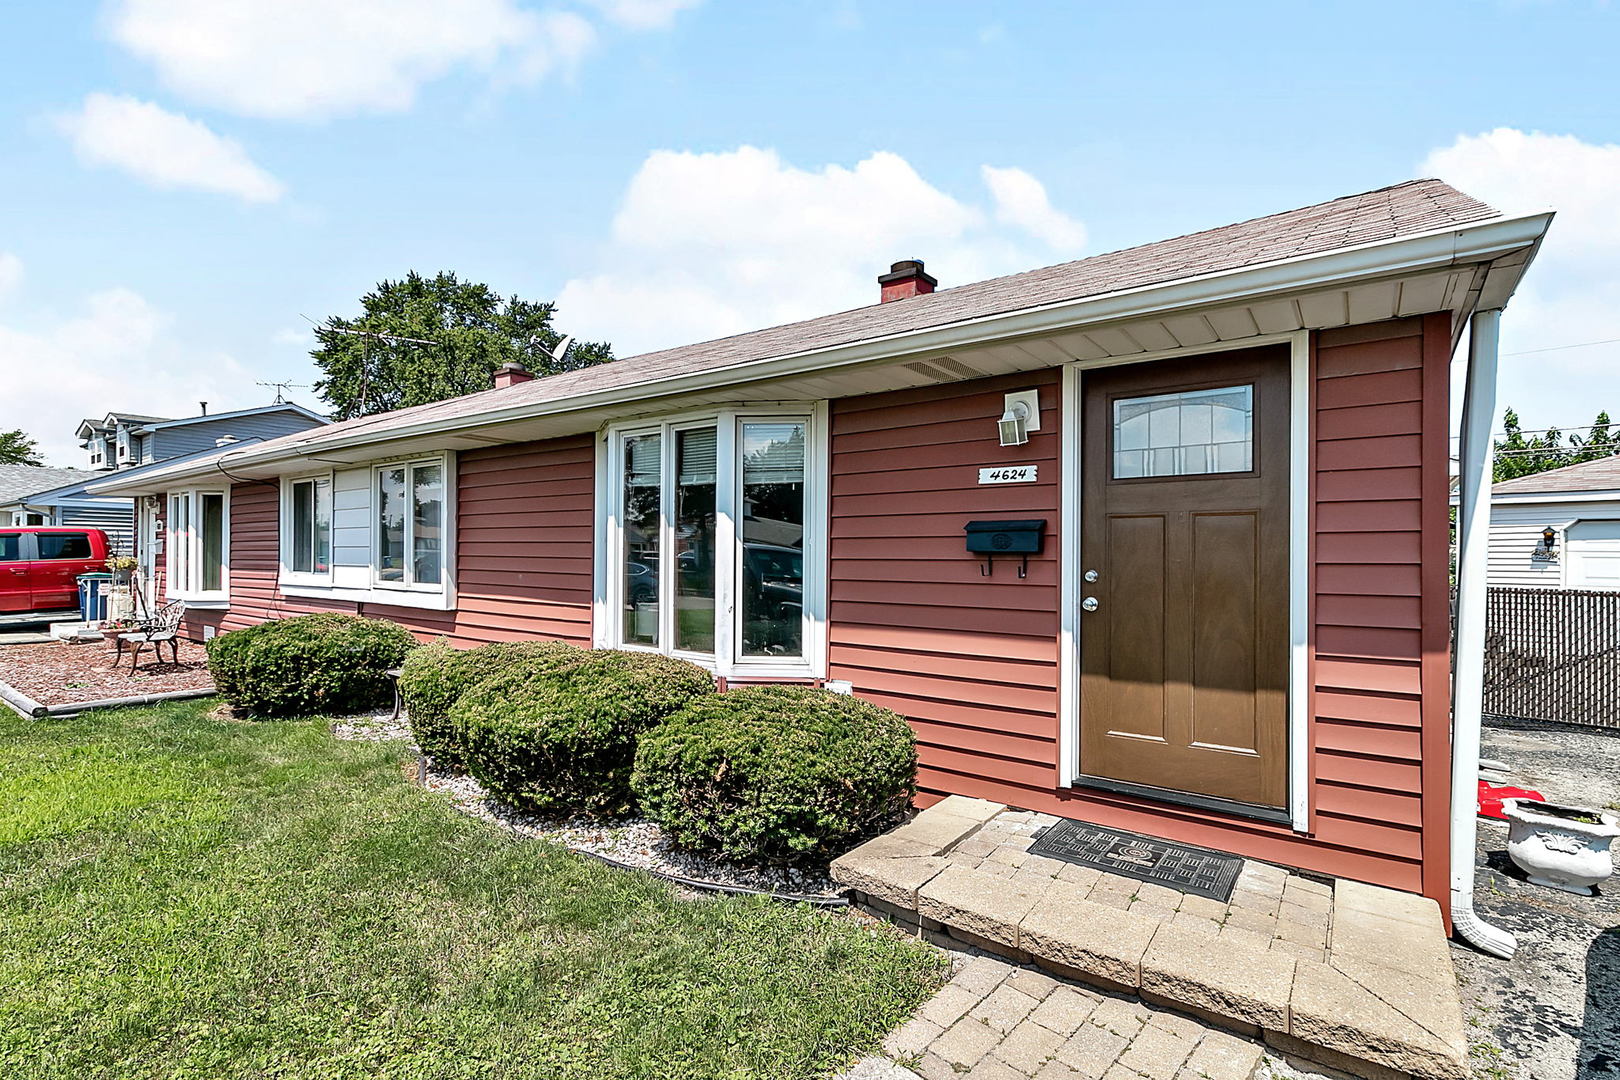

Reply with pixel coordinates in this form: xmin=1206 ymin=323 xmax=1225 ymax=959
xmin=1452 ymin=308 xmax=1518 ymax=960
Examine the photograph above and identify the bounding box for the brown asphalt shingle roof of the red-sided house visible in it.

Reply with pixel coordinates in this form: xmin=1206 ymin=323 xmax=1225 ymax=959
xmin=208 ymin=180 xmax=1500 ymax=459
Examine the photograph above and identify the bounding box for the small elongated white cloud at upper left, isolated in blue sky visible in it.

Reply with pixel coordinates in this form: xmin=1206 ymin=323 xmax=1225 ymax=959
xmin=57 ymin=94 xmax=285 ymax=202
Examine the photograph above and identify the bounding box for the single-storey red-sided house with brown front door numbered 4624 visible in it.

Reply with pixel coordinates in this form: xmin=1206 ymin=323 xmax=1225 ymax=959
xmin=91 ymin=180 xmax=1550 ymax=958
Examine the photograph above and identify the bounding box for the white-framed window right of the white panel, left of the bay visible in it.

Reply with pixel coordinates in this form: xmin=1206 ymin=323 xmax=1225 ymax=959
xmin=371 ymin=458 xmax=446 ymax=593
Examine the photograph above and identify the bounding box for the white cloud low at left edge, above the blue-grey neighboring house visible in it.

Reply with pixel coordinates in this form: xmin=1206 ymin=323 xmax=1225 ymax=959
xmin=0 ymin=288 xmax=257 ymax=466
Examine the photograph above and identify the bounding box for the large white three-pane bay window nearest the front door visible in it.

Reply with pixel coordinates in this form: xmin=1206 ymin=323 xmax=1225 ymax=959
xmin=603 ymin=410 xmax=826 ymax=675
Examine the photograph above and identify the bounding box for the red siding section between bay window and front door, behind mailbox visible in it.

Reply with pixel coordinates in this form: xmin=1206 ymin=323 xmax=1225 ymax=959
xmin=828 ymin=371 xmax=1059 ymax=819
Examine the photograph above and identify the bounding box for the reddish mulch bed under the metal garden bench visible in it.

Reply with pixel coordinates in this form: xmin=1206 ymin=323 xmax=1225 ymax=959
xmin=0 ymin=641 xmax=214 ymax=704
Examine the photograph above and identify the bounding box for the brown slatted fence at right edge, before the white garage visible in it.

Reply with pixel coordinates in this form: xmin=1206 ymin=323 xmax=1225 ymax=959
xmin=1484 ymin=588 xmax=1620 ymax=727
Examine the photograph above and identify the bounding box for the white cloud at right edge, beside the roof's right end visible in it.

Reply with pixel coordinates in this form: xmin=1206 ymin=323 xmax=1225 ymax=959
xmin=1422 ymin=128 xmax=1620 ymax=427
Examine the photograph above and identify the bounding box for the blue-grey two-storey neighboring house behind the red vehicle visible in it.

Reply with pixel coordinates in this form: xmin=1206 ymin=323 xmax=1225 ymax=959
xmin=15 ymin=403 xmax=327 ymax=554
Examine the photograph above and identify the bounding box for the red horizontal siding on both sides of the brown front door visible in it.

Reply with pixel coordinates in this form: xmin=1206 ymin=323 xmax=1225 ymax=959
xmin=828 ymin=317 xmax=1450 ymax=895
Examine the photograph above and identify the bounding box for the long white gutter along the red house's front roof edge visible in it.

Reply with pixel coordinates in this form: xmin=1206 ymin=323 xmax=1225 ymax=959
xmin=91 ymin=212 xmax=1552 ymax=492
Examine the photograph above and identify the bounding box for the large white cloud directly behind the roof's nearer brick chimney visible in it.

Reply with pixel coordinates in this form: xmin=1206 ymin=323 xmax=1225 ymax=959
xmin=557 ymin=146 xmax=1084 ymax=356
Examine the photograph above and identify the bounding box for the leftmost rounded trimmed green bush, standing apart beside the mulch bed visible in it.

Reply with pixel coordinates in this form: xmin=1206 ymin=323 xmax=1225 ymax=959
xmin=207 ymin=612 xmax=416 ymax=716
